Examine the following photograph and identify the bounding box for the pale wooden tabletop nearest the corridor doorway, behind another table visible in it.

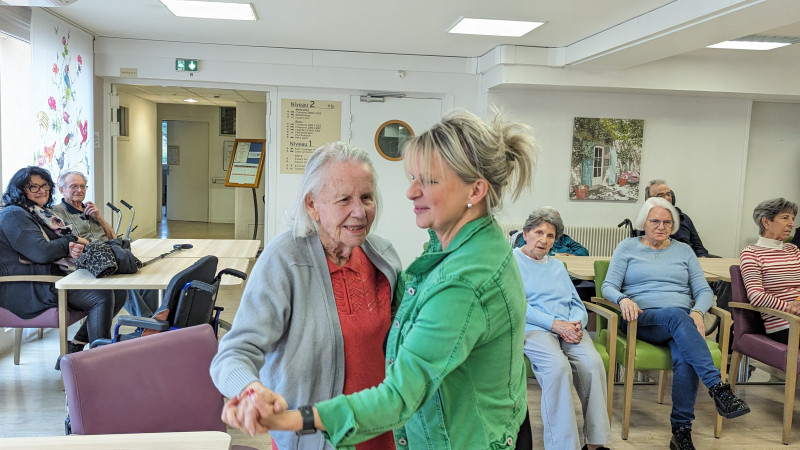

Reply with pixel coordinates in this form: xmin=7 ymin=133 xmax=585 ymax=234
xmin=131 ymin=239 xmax=261 ymax=262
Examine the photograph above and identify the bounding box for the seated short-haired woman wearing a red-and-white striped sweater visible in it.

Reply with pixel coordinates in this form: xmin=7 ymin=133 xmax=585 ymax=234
xmin=741 ymin=198 xmax=800 ymax=344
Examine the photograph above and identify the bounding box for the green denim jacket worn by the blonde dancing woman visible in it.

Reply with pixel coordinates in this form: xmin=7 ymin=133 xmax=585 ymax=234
xmin=316 ymin=216 xmax=527 ymax=450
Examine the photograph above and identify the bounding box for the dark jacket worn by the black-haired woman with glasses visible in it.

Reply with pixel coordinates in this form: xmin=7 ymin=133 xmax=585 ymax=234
xmin=0 ymin=206 xmax=78 ymax=319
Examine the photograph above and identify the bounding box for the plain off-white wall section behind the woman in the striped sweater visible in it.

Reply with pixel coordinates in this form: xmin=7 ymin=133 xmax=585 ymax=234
xmin=740 ymin=102 xmax=800 ymax=247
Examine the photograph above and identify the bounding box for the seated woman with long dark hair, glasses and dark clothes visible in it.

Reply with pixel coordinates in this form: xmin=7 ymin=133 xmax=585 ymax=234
xmin=0 ymin=166 xmax=125 ymax=369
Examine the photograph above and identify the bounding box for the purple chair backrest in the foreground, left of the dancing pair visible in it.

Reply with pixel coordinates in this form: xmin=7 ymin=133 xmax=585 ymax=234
xmin=61 ymin=325 xmax=226 ymax=434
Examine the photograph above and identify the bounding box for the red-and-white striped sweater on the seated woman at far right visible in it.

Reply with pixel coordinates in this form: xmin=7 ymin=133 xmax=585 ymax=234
xmin=741 ymin=237 xmax=800 ymax=333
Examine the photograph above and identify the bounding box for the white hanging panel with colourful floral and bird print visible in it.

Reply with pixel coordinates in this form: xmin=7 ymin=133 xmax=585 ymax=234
xmin=31 ymin=13 xmax=94 ymax=198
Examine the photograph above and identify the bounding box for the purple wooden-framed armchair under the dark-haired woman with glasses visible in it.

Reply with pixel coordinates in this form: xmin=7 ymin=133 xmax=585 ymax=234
xmin=0 ymin=275 xmax=86 ymax=365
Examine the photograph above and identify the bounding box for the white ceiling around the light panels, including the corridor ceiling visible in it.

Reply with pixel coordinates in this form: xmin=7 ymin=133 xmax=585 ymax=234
xmin=37 ymin=0 xmax=800 ymax=106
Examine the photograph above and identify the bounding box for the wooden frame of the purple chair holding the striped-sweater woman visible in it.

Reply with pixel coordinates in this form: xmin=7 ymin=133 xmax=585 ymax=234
xmin=728 ymin=302 xmax=800 ymax=445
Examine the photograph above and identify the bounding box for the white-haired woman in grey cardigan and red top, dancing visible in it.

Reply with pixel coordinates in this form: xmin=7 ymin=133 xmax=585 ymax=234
xmin=211 ymin=142 xmax=400 ymax=450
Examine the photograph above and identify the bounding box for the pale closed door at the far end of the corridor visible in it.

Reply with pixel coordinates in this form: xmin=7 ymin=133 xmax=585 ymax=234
xmin=167 ymin=120 xmax=209 ymax=222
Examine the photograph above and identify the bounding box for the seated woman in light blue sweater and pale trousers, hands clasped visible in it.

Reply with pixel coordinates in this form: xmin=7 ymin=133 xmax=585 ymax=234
xmin=514 ymin=208 xmax=610 ymax=450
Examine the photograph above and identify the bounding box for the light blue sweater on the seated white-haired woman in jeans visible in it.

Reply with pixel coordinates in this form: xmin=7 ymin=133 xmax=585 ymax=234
xmin=602 ymin=237 xmax=714 ymax=313
